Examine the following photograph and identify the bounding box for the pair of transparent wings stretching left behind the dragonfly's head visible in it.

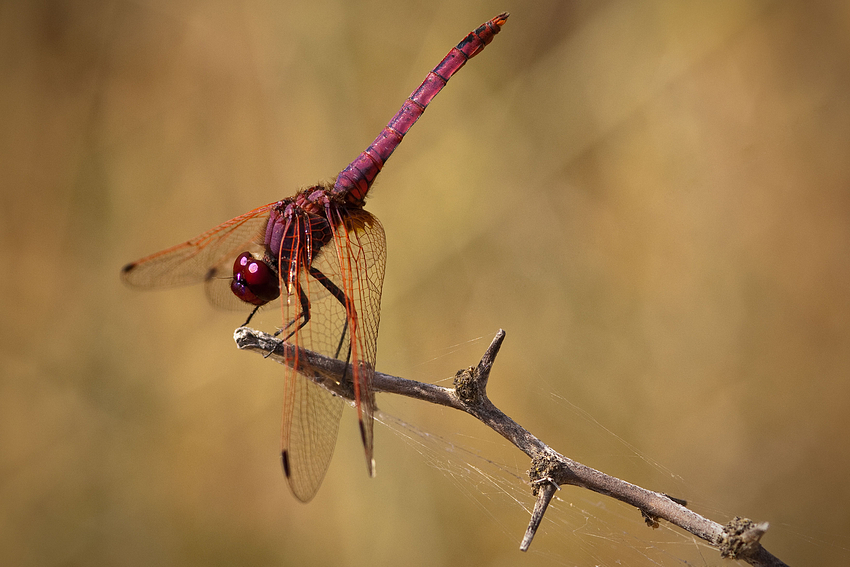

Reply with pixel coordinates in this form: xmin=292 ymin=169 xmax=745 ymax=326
xmin=121 ymin=203 xmax=276 ymax=308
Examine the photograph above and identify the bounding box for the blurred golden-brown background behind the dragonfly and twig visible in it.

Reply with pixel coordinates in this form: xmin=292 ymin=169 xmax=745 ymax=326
xmin=0 ymin=0 xmax=850 ymax=565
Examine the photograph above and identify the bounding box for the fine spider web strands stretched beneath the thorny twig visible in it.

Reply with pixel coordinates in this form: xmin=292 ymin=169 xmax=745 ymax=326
xmin=376 ymin=412 xmax=720 ymax=566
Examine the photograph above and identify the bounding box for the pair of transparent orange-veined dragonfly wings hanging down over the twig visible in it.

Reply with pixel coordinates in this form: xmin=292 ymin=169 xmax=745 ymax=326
xmin=281 ymin=209 xmax=385 ymax=502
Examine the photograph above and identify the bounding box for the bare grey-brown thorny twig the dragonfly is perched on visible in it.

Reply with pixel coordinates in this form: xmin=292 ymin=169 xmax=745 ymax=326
xmin=234 ymin=327 xmax=785 ymax=567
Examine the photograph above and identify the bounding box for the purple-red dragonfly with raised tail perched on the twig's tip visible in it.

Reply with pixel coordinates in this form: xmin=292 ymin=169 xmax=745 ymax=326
xmin=121 ymin=12 xmax=509 ymax=502
